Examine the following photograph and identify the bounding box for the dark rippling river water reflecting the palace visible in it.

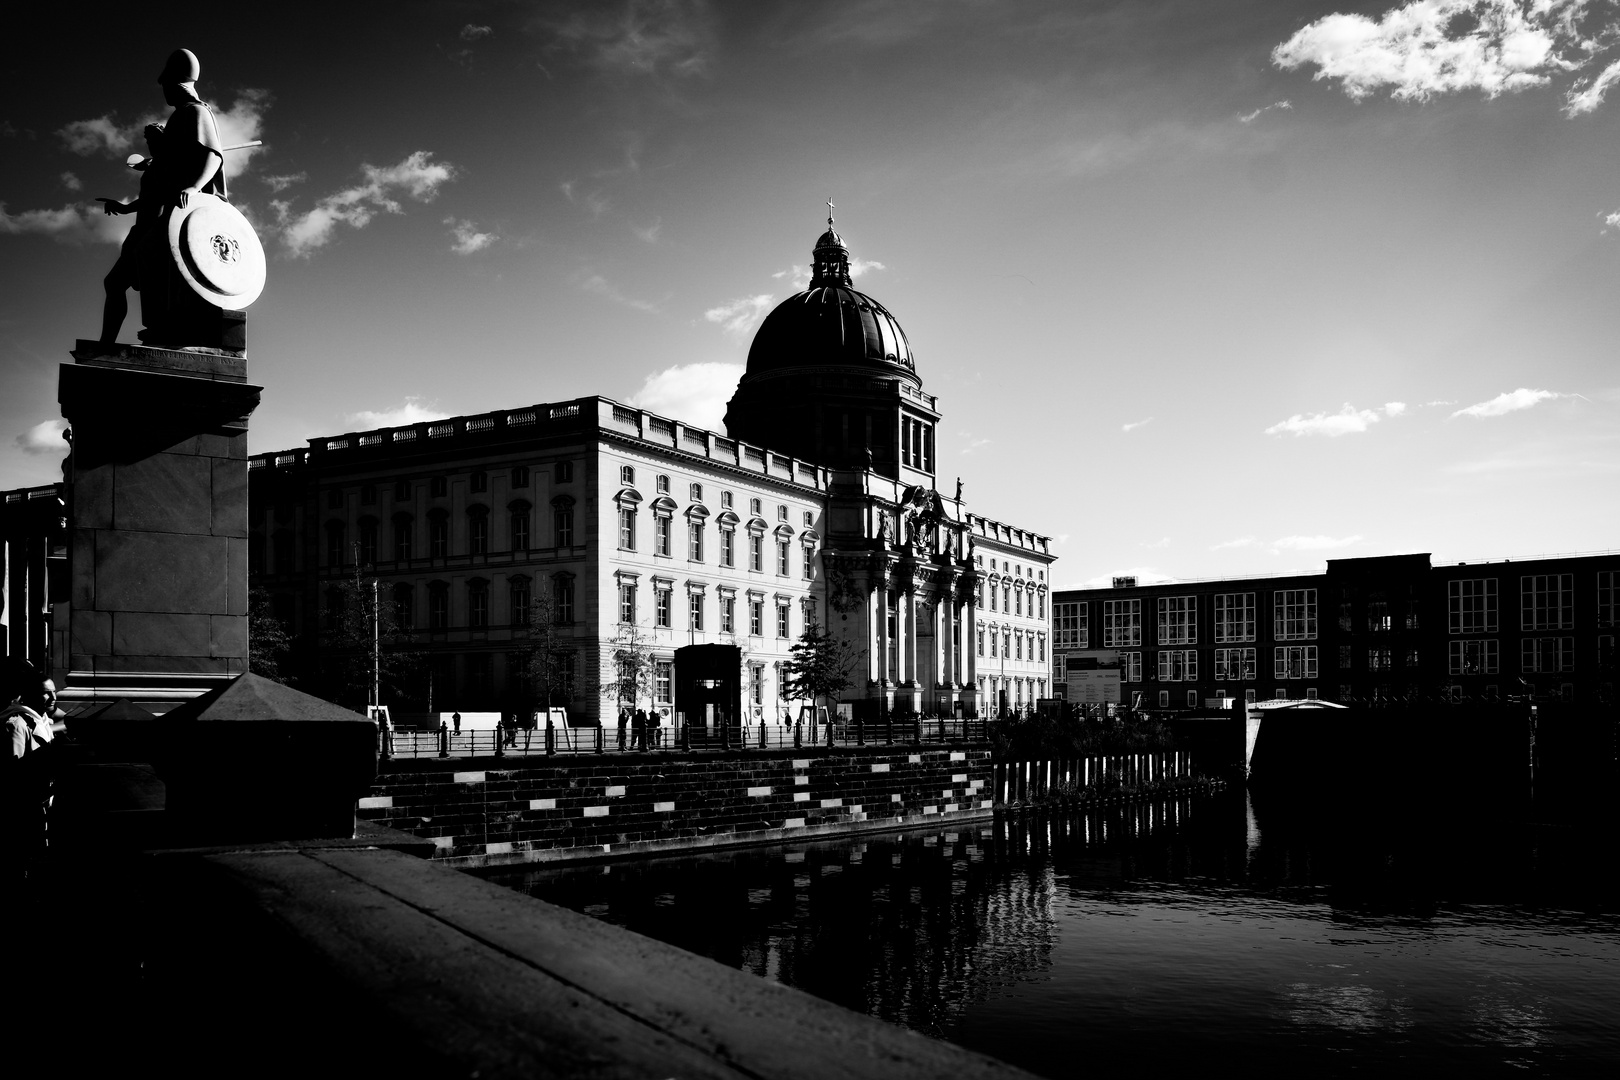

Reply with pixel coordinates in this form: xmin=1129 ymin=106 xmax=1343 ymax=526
xmin=494 ymin=789 xmax=1620 ymax=1077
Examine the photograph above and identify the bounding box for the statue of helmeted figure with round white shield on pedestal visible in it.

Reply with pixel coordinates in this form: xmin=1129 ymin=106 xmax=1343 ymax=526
xmin=97 ymin=49 xmax=264 ymax=347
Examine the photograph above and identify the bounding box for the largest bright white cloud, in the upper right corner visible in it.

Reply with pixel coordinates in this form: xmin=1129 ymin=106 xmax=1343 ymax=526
xmin=1272 ymin=0 xmax=1620 ymax=117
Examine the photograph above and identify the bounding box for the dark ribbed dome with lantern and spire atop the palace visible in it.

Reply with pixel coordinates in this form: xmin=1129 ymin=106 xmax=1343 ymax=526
xmin=744 ymin=219 xmax=917 ymax=379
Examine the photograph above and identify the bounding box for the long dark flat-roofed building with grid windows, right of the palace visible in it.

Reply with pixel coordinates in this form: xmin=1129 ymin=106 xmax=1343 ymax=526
xmin=1053 ymin=554 xmax=1620 ymax=709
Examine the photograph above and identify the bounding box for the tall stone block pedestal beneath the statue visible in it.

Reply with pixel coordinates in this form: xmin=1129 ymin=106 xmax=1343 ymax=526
xmin=53 ymin=338 xmax=261 ymax=712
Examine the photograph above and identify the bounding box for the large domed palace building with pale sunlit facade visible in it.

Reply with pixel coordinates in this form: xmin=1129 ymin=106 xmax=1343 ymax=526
xmin=248 ymin=219 xmax=1053 ymax=722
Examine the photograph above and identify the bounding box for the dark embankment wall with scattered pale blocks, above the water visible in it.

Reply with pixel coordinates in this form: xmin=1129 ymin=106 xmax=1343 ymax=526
xmin=360 ymin=746 xmax=993 ymax=866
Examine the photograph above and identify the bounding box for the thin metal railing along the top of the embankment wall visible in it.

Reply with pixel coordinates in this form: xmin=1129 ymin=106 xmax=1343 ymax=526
xmin=377 ymin=717 xmax=995 ymax=759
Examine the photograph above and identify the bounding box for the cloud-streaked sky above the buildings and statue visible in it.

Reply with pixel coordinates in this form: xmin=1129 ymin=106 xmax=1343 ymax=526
xmin=0 ymin=0 xmax=1620 ymax=586
